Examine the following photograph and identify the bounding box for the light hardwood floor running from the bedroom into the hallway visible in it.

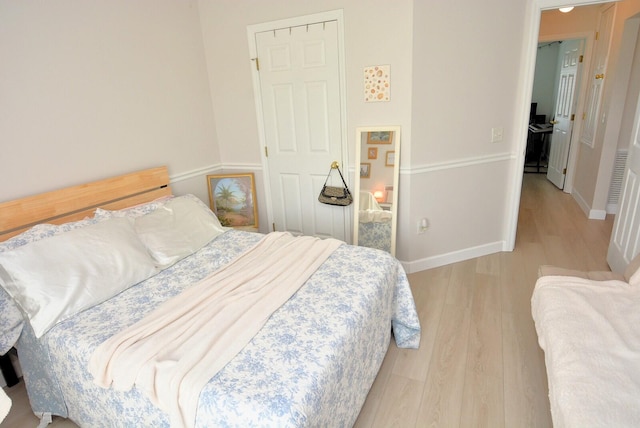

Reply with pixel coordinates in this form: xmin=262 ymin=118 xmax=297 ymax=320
xmin=0 ymin=174 xmax=613 ymax=428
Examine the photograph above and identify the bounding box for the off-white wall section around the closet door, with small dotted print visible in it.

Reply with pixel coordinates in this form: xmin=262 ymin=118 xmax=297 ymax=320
xmin=199 ymin=0 xmax=412 ymax=232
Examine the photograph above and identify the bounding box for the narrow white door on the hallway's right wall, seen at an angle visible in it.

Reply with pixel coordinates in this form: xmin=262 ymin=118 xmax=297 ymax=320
xmin=580 ymin=4 xmax=616 ymax=147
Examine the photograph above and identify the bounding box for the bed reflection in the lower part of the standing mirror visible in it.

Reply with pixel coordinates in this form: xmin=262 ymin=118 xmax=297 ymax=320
xmin=358 ymin=191 xmax=393 ymax=252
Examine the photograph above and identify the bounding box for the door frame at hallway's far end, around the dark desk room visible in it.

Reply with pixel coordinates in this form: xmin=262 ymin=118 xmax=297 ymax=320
xmin=539 ymin=31 xmax=595 ymax=193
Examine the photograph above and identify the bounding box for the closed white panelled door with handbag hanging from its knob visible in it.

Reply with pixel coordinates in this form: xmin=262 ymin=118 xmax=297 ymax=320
xmin=255 ymin=21 xmax=350 ymax=240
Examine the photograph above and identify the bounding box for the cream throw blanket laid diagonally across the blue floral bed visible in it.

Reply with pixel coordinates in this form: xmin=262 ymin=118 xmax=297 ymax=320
xmin=89 ymin=232 xmax=342 ymax=426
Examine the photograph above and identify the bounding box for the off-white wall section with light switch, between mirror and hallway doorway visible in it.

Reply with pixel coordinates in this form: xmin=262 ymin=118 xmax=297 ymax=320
xmin=408 ymin=0 xmax=528 ymax=270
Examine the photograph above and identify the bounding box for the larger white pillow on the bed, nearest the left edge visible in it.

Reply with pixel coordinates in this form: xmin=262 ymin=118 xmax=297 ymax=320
xmin=0 ymin=218 xmax=157 ymax=337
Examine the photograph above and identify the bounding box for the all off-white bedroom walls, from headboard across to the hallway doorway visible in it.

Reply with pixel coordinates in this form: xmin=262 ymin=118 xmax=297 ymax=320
xmin=6 ymin=0 xmax=631 ymax=270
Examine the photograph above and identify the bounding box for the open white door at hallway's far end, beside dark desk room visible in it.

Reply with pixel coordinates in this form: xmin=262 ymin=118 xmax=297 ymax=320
xmin=547 ymin=40 xmax=583 ymax=189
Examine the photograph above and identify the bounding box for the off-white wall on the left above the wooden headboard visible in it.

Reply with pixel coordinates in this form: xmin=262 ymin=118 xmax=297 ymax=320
xmin=0 ymin=0 xmax=220 ymax=201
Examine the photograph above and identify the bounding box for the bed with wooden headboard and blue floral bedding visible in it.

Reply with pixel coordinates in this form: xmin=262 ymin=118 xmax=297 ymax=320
xmin=0 ymin=167 xmax=420 ymax=427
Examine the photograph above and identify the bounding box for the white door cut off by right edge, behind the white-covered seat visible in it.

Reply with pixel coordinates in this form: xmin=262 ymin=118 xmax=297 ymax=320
xmin=607 ymin=88 xmax=640 ymax=273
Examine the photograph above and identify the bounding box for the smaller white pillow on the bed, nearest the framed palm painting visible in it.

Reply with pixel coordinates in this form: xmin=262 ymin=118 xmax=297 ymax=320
xmin=135 ymin=196 xmax=227 ymax=268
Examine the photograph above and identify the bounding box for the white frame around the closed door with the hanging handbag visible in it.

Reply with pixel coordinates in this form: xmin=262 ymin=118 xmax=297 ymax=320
xmin=247 ymin=9 xmax=352 ymax=239
